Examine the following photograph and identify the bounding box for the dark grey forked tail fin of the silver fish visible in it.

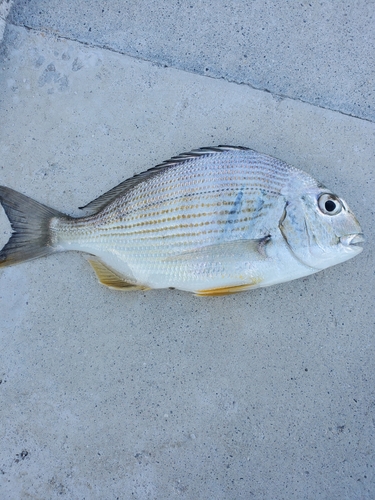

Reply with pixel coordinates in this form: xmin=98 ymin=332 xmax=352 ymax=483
xmin=0 ymin=186 xmax=65 ymax=267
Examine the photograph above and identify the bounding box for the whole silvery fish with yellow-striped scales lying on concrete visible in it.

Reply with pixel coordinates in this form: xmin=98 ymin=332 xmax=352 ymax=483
xmin=0 ymin=146 xmax=364 ymax=296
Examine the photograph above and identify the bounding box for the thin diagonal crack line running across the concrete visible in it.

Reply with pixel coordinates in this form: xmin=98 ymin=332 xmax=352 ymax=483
xmin=0 ymin=19 xmax=375 ymax=123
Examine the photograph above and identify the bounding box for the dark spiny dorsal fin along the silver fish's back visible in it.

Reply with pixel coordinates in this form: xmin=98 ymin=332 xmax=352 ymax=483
xmin=79 ymin=146 xmax=248 ymax=214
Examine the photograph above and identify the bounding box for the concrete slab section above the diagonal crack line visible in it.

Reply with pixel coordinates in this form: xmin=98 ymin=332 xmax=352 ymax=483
xmin=10 ymin=0 xmax=375 ymax=121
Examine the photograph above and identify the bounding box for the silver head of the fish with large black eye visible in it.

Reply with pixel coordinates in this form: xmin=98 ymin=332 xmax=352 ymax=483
xmin=279 ymin=183 xmax=365 ymax=270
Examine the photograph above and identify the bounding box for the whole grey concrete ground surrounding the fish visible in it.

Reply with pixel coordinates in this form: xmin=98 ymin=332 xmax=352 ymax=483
xmin=0 ymin=0 xmax=375 ymax=500
